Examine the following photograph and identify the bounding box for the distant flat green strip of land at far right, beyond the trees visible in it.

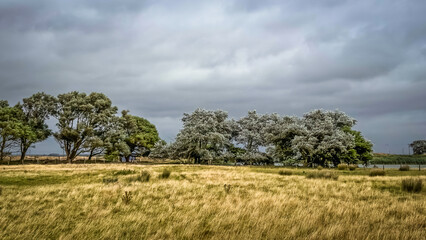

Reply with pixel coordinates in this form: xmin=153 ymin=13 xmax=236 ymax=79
xmin=371 ymin=153 xmax=426 ymax=164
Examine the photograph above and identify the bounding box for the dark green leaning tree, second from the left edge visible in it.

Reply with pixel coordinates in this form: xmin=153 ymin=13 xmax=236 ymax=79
xmin=15 ymin=92 xmax=55 ymax=163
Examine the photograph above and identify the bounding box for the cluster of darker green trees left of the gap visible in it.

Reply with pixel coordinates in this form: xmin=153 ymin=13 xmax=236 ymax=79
xmin=0 ymin=91 xmax=160 ymax=163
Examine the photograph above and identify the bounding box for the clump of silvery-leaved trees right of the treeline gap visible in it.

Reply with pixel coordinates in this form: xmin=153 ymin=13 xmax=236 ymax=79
xmin=150 ymin=109 xmax=372 ymax=166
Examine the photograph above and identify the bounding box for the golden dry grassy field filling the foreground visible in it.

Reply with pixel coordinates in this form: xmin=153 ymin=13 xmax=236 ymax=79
xmin=0 ymin=164 xmax=426 ymax=239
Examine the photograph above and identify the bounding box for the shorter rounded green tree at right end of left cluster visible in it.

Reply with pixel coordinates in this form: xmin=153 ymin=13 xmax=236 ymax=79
xmin=121 ymin=111 xmax=160 ymax=161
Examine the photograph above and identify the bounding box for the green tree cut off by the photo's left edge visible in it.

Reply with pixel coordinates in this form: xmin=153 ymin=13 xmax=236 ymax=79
xmin=0 ymin=100 xmax=23 ymax=162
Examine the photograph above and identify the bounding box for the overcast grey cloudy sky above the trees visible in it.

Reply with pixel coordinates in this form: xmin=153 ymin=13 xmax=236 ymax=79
xmin=0 ymin=0 xmax=426 ymax=154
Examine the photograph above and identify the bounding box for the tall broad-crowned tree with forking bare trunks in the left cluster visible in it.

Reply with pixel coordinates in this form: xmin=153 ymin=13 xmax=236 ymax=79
xmin=54 ymin=91 xmax=117 ymax=163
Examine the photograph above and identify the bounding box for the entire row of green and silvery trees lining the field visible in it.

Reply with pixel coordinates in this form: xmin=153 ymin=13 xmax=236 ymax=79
xmin=0 ymin=91 xmax=372 ymax=166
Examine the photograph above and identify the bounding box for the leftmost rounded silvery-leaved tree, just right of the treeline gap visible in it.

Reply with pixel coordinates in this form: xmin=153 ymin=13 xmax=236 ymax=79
xmin=173 ymin=108 xmax=234 ymax=163
